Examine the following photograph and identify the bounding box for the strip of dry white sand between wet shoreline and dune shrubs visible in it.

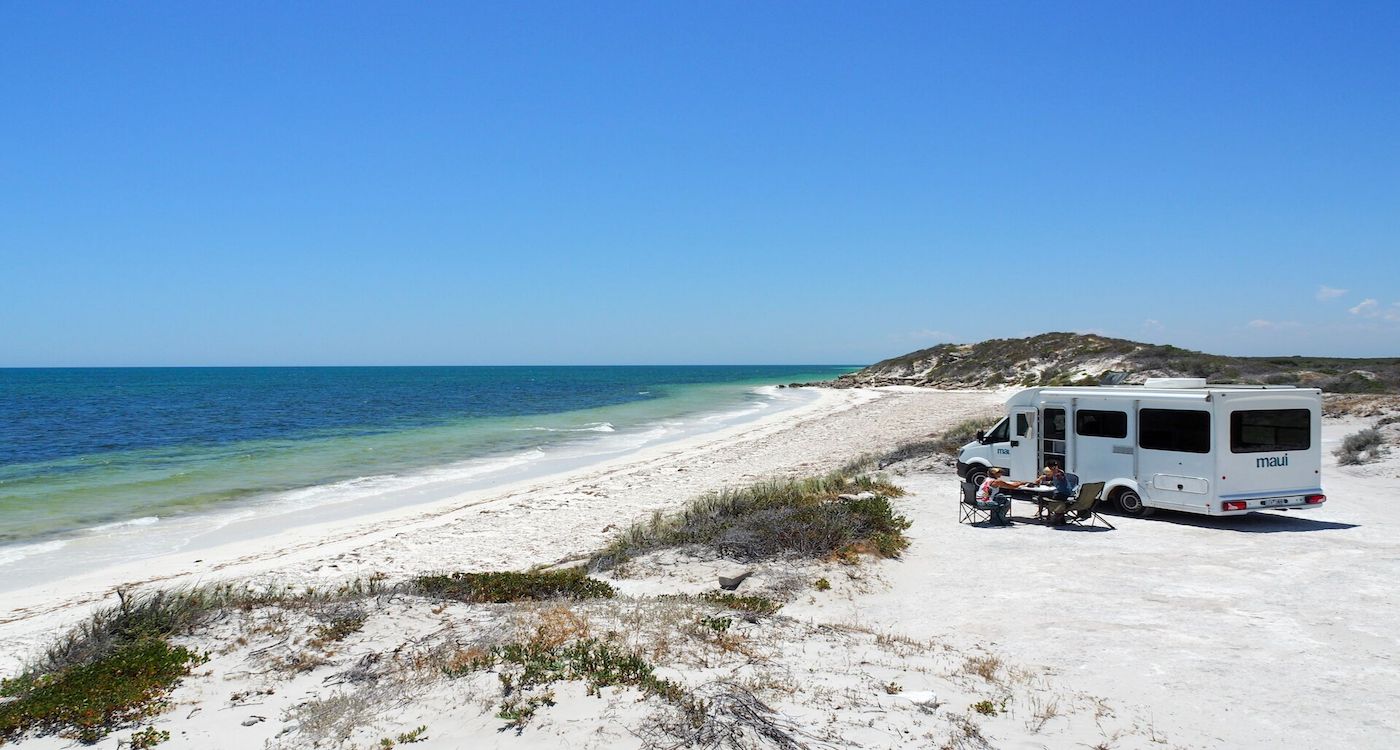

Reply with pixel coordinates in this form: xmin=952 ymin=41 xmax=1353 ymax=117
xmin=0 ymin=389 xmax=995 ymax=674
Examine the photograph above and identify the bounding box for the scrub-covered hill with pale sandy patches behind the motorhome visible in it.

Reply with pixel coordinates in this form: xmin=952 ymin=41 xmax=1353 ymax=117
xmin=829 ymin=333 xmax=1400 ymax=393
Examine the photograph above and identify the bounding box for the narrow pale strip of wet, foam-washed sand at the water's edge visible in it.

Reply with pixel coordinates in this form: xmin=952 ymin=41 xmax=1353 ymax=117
xmin=0 ymin=386 xmax=820 ymax=596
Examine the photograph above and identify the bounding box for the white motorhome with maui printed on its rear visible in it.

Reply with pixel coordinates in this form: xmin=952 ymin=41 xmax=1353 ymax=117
xmin=958 ymin=378 xmax=1327 ymax=516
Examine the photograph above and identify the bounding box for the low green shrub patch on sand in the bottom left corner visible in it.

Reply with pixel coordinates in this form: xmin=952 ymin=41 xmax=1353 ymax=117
xmin=0 ymin=637 xmax=203 ymax=743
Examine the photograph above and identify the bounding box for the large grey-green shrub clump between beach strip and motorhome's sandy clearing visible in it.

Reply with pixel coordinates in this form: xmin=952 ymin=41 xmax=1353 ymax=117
xmin=589 ymin=466 xmax=909 ymax=569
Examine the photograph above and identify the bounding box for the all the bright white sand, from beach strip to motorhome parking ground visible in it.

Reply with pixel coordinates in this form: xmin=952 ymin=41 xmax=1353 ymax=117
xmin=0 ymin=388 xmax=1400 ymax=749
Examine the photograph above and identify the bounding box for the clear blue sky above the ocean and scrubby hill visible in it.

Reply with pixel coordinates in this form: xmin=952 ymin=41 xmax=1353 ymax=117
xmin=0 ymin=0 xmax=1400 ymax=365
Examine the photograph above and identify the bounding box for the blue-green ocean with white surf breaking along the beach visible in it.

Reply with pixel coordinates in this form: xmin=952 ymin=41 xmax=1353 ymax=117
xmin=0 ymin=365 xmax=854 ymax=576
